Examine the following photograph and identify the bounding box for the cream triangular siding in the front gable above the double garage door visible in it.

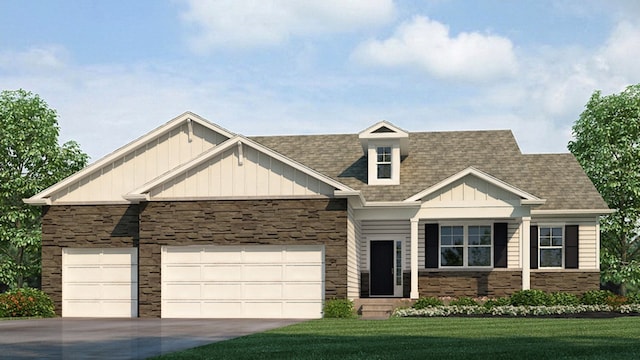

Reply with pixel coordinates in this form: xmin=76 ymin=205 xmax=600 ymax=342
xmin=150 ymin=146 xmax=334 ymax=198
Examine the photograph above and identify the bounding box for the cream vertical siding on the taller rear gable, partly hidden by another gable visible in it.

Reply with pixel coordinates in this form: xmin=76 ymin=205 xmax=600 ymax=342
xmin=51 ymin=122 xmax=228 ymax=202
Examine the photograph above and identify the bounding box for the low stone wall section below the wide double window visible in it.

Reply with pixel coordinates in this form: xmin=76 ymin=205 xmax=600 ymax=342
xmin=418 ymin=270 xmax=522 ymax=297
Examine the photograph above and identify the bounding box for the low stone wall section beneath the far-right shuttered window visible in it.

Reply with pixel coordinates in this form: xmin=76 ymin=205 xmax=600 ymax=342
xmin=531 ymin=270 xmax=600 ymax=295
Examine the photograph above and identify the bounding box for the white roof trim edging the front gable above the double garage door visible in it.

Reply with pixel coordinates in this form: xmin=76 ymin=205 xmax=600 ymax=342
xmin=124 ymin=135 xmax=355 ymax=202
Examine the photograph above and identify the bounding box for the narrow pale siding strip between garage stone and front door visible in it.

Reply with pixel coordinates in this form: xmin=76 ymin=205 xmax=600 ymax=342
xmin=347 ymin=204 xmax=362 ymax=299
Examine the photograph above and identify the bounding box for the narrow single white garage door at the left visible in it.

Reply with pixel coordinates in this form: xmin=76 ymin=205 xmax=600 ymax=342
xmin=62 ymin=248 xmax=138 ymax=317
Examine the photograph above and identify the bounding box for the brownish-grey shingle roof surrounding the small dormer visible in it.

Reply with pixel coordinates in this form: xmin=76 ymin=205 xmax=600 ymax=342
xmin=251 ymin=130 xmax=607 ymax=210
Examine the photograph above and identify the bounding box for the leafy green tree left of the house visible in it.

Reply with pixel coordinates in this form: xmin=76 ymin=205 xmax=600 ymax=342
xmin=0 ymin=89 xmax=88 ymax=288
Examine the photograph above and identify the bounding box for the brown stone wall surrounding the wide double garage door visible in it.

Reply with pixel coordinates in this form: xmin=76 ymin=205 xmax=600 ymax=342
xmin=138 ymin=199 xmax=347 ymax=317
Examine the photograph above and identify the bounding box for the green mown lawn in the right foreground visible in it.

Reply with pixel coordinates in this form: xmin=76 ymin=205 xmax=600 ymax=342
xmin=154 ymin=317 xmax=640 ymax=360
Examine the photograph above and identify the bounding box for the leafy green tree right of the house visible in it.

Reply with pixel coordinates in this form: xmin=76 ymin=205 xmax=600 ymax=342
xmin=569 ymin=84 xmax=640 ymax=294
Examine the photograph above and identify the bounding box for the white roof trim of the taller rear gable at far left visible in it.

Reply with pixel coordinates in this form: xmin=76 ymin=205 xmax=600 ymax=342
xmin=24 ymin=111 xmax=235 ymax=205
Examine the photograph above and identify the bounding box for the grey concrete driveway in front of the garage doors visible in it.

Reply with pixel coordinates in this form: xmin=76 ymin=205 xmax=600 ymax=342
xmin=0 ymin=318 xmax=300 ymax=359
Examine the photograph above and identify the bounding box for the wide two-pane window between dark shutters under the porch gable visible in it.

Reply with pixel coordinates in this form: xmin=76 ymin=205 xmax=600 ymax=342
xmin=440 ymin=225 xmax=493 ymax=267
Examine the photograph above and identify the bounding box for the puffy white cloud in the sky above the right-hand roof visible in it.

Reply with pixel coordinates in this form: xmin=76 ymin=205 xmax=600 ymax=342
xmin=352 ymin=16 xmax=518 ymax=82
